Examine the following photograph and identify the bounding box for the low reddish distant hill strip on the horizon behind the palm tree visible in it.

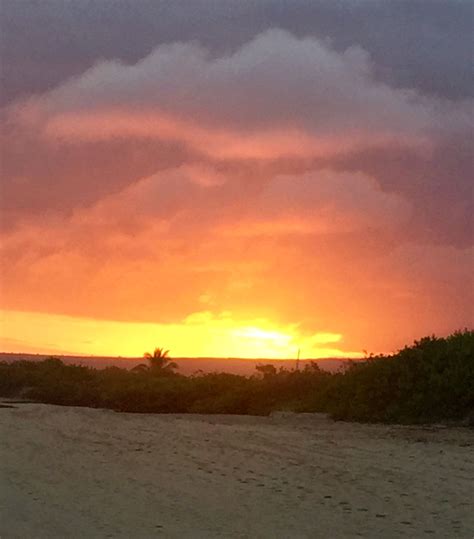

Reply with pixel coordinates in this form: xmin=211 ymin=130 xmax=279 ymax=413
xmin=0 ymin=352 xmax=347 ymax=376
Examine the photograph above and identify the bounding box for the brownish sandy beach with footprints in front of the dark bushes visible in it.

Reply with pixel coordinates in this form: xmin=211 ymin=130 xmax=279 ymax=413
xmin=0 ymin=404 xmax=474 ymax=539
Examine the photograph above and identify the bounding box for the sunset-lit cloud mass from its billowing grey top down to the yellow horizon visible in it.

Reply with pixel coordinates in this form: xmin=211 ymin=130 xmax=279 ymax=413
xmin=0 ymin=31 xmax=474 ymax=358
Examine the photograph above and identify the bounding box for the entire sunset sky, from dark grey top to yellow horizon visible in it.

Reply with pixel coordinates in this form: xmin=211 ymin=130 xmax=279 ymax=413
xmin=0 ymin=0 xmax=474 ymax=358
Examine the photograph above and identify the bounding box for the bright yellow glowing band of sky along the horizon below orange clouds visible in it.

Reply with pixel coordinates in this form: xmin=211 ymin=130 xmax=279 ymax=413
xmin=0 ymin=311 xmax=361 ymax=359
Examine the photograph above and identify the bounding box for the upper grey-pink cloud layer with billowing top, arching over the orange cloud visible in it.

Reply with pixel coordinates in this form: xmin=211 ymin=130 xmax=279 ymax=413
xmin=2 ymin=30 xmax=473 ymax=251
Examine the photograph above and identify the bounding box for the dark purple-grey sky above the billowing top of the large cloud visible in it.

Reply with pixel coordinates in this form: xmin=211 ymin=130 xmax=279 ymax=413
xmin=0 ymin=0 xmax=473 ymax=103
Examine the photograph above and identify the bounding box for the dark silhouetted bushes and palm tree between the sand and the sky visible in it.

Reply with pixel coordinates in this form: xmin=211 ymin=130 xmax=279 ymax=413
xmin=0 ymin=330 xmax=474 ymax=423
